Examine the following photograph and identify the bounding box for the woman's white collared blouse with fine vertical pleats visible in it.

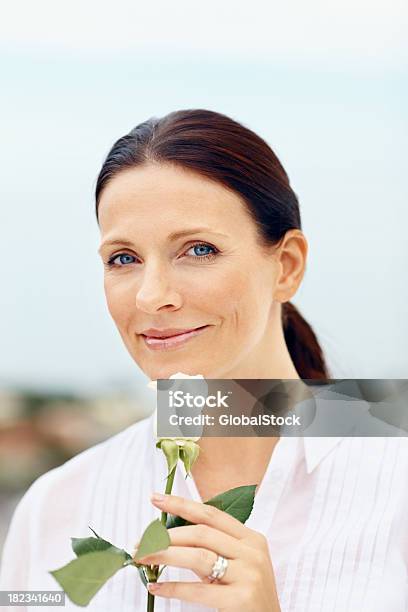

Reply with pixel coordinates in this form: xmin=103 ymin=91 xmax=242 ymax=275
xmin=0 ymin=408 xmax=408 ymax=612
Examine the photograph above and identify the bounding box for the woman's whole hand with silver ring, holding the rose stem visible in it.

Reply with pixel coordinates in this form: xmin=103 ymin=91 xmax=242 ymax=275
xmin=138 ymin=493 xmax=280 ymax=612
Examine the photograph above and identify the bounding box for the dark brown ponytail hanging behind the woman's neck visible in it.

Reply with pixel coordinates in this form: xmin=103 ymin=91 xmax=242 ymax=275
xmin=282 ymin=302 xmax=330 ymax=379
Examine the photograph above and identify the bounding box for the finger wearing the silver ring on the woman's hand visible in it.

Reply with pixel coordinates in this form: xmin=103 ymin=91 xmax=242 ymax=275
xmin=138 ymin=546 xmax=234 ymax=584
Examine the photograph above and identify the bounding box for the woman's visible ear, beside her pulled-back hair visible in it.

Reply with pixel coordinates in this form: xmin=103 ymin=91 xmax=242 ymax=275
xmin=274 ymin=229 xmax=308 ymax=303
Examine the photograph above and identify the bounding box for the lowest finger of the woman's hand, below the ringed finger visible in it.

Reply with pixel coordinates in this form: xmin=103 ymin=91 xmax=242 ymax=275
xmin=148 ymin=582 xmax=237 ymax=609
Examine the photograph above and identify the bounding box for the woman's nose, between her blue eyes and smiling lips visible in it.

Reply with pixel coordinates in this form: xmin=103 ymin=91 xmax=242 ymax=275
xmin=136 ymin=265 xmax=181 ymax=313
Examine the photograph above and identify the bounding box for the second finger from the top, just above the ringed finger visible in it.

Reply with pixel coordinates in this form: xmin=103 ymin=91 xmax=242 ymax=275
xmin=168 ymin=525 xmax=241 ymax=559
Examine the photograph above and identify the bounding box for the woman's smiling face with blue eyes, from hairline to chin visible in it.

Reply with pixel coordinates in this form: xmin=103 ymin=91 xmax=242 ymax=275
xmin=99 ymin=164 xmax=286 ymax=379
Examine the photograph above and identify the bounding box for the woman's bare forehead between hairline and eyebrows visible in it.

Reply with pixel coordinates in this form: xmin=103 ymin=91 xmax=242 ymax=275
xmin=99 ymin=164 xmax=250 ymax=233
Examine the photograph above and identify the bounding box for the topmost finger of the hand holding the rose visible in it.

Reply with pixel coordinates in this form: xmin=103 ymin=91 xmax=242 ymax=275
xmin=151 ymin=493 xmax=247 ymax=539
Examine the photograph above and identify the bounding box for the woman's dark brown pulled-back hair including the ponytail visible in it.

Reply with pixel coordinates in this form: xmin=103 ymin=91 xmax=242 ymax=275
xmin=95 ymin=109 xmax=328 ymax=379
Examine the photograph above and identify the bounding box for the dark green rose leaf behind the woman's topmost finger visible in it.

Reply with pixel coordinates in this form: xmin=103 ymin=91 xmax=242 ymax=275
xmin=166 ymin=485 xmax=257 ymax=529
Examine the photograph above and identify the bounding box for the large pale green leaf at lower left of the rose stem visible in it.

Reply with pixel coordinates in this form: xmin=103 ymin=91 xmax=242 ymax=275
xmin=49 ymin=549 xmax=126 ymax=606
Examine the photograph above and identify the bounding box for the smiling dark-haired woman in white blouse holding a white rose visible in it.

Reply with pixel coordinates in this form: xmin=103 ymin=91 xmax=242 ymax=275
xmin=1 ymin=110 xmax=408 ymax=612
